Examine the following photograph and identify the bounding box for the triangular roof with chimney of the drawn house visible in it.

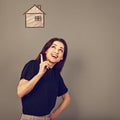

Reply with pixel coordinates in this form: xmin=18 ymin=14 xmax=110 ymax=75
xmin=24 ymin=4 xmax=45 ymax=14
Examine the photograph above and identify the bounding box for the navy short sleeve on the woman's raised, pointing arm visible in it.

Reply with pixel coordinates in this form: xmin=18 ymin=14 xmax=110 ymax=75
xmin=20 ymin=60 xmax=35 ymax=80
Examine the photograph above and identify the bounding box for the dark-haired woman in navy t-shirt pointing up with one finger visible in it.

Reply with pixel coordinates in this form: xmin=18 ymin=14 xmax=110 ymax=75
xmin=17 ymin=38 xmax=70 ymax=120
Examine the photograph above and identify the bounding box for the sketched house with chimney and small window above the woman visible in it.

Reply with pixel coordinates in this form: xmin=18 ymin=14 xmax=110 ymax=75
xmin=24 ymin=5 xmax=45 ymax=28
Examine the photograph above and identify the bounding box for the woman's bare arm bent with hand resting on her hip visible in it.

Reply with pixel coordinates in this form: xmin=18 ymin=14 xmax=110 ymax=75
xmin=49 ymin=92 xmax=70 ymax=120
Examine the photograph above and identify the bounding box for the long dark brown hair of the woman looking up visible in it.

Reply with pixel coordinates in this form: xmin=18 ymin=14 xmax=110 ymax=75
xmin=36 ymin=38 xmax=68 ymax=72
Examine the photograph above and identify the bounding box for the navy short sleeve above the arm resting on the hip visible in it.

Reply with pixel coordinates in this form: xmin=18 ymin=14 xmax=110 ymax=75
xmin=58 ymin=74 xmax=68 ymax=97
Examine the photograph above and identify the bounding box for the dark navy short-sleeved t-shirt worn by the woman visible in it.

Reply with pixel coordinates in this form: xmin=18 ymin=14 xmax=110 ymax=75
xmin=20 ymin=60 xmax=68 ymax=116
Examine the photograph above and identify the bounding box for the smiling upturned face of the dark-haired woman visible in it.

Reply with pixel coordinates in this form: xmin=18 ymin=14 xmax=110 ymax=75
xmin=45 ymin=41 xmax=64 ymax=64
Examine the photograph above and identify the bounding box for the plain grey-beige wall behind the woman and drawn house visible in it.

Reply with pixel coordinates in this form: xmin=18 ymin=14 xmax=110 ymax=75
xmin=0 ymin=0 xmax=120 ymax=120
